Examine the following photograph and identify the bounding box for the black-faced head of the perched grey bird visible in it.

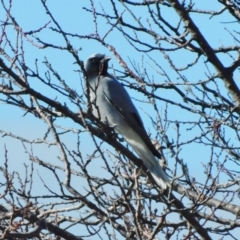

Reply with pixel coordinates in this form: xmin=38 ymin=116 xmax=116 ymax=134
xmin=84 ymin=53 xmax=110 ymax=77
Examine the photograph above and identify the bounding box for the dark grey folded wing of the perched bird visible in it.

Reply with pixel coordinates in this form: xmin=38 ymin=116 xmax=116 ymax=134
xmin=104 ymin=78 xmax=161 ymax=158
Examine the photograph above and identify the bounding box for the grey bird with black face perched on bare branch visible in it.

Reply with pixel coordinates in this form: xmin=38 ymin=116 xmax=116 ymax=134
xmin=84 ymin=53 xmax=170 ymax=189
